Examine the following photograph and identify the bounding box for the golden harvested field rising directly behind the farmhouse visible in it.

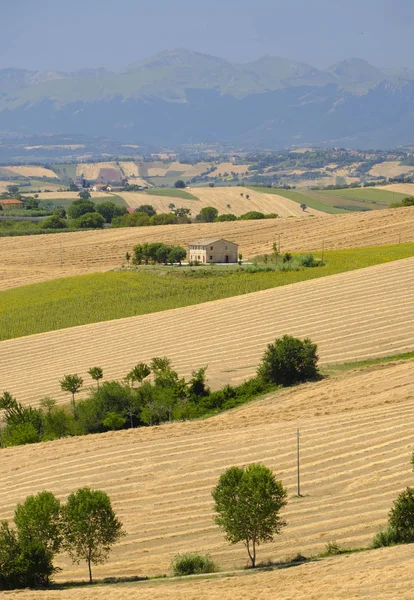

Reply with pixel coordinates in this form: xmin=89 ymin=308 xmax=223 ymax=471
xmin=0 ymin=206 xmax=414 ymax=290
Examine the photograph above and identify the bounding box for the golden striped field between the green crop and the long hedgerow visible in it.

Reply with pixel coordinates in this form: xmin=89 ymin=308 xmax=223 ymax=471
xmin=0 ymin=258 xmax=414 ymax=404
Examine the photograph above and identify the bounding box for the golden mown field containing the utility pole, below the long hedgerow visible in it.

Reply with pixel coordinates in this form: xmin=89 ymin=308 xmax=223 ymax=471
xmin=0 ymin=361 xmax=414 ymax=579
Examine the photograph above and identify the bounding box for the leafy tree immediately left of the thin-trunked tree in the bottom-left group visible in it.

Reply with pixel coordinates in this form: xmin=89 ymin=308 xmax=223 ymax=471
xmin=14 ymin=491 xmax=62 ymax=558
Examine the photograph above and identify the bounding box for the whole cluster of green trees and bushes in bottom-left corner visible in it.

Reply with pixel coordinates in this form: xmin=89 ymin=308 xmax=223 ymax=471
xmin=0 ymin=488 xmax=125 ymax=590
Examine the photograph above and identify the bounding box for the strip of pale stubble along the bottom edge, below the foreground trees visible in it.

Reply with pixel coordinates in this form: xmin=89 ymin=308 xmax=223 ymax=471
xmin=5 ymin=546 xmax=413 ymax=600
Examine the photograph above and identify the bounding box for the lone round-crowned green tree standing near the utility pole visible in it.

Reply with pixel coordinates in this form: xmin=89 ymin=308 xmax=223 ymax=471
xmin=212 ymin=464 xmax=287 ymax=568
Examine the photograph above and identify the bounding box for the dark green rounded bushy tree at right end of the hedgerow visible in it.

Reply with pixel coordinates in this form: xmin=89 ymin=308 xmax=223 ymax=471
xmin=257 ymin=335 xmax=319 ymax=386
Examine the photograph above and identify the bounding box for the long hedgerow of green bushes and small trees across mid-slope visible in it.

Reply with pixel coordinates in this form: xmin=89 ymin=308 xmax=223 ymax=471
xmin=0 ymin=336 xmax=318 ymax=447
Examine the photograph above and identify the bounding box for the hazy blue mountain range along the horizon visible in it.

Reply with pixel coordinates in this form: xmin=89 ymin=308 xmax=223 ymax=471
xmin=0 ymin=49 xmax=414 ymax=149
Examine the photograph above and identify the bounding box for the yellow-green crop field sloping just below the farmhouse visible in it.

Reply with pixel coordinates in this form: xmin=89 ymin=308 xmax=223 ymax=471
xmin=0 ymin=243 xmax=414 ymax=340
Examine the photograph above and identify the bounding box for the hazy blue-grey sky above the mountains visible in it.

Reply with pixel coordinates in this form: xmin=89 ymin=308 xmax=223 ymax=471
xmin=0 ymin=0 xmax=414 ymax=70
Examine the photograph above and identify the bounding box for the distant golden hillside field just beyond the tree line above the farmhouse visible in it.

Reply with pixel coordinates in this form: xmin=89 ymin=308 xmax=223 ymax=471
xmin=119 ymin=187 xmax=326 ymax=218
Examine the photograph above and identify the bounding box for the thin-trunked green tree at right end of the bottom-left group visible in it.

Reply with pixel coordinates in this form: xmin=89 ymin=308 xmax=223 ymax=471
xmin=62 ymin=488 xmax=125 ymax=583
